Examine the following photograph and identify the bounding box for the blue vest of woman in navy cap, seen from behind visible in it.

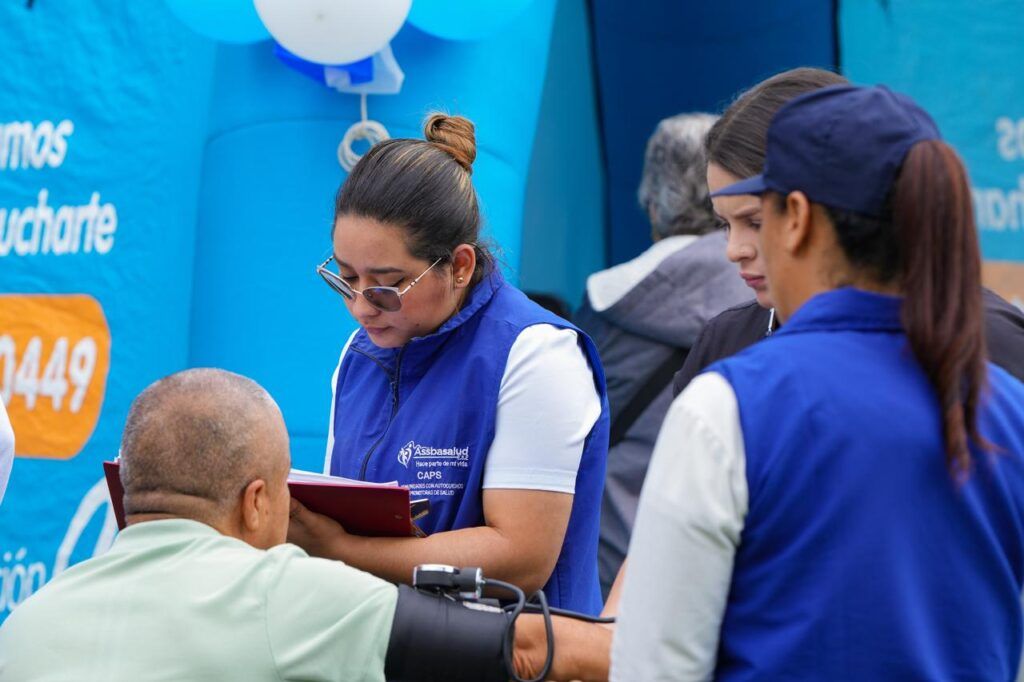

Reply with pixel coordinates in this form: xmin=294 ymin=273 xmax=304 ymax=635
xmin=708 ymin=289 xmax=1024 ymax=680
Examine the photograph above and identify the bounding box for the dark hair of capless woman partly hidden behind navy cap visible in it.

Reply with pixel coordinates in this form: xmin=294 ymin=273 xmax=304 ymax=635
xmin=705 ymin=67 xmax=849 ymax=178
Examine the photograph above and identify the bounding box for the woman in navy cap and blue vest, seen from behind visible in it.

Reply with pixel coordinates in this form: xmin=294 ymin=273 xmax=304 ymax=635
xmin=612 ymin=86 xmax=1024 ymax=680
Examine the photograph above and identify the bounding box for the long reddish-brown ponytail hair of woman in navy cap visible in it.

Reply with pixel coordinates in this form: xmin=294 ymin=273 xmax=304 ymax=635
xmin=773 ymin=140 xmax=990 ymax=477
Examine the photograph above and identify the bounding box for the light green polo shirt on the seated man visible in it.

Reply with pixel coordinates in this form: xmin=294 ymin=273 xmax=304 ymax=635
xmin=0 ymin=519 xmax=397 ymax=682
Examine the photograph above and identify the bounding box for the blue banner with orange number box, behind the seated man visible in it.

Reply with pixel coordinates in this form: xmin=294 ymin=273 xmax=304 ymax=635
xmin=0 ymin=0 xmax=213 ymax=620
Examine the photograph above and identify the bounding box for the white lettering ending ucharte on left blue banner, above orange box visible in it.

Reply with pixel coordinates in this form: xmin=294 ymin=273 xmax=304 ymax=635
xmin=0 ymin=120 xmax=118 ymax=258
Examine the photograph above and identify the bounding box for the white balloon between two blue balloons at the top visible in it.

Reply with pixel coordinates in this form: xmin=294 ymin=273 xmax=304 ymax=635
xmin=255 ymin=0 xmax=413 ymax=65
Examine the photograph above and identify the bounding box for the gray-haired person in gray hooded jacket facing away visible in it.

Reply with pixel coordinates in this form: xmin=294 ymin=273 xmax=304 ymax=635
xmin=574 ymin=114 xmax=751 ymax=595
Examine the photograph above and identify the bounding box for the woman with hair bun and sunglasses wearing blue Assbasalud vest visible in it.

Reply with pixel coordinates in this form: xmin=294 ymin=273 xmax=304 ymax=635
xmin=290 ymin=115 xmax=608 ymax=613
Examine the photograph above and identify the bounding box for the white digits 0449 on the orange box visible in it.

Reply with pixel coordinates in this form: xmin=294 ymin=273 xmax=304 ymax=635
xmin=0 ymin=334 xmax=97 ymax=414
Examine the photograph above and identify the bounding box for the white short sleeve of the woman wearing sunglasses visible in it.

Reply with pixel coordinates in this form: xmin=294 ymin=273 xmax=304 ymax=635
xmin=483 ymin=325 xmax=601 ymax=493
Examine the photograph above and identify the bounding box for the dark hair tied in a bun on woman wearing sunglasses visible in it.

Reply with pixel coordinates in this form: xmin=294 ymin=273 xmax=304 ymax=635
xmin=332 ymin=114 xmax=494 ymax=284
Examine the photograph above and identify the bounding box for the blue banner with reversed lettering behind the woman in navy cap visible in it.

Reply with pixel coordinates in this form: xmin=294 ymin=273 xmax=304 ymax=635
xmin=840 ymin=0 xmax=1024 ymax=305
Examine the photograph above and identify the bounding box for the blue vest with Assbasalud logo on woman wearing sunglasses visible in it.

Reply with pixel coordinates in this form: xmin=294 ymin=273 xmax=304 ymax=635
xmin=331 ymin=272 xmax=608 ymax=613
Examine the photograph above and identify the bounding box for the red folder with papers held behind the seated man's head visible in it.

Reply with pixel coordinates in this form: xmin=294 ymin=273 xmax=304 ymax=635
xmin=103 ymin=462 xmax=414 ymax=538
